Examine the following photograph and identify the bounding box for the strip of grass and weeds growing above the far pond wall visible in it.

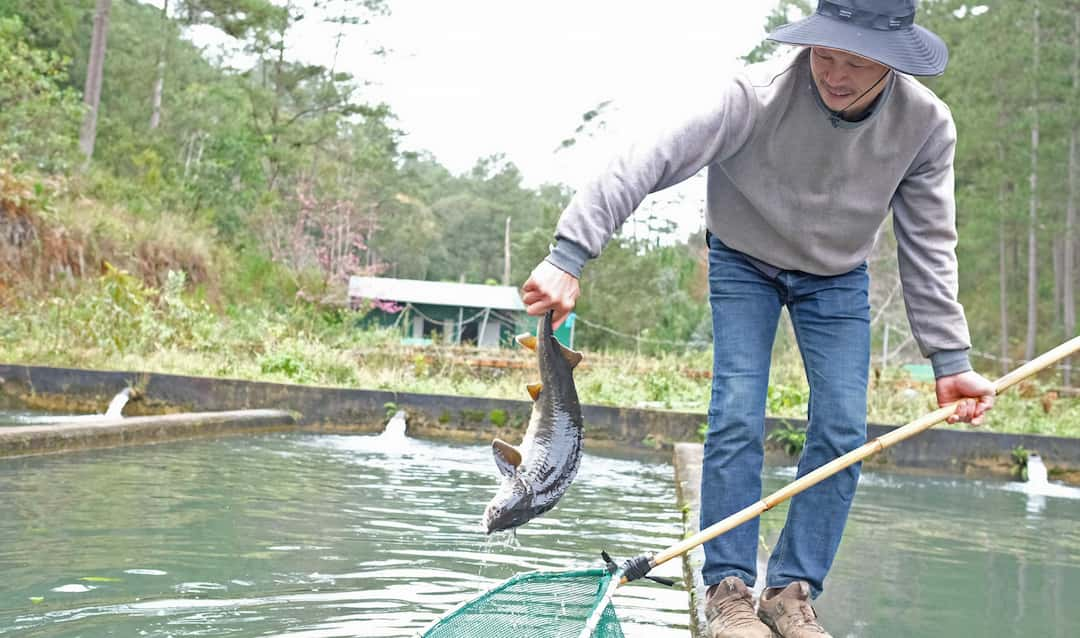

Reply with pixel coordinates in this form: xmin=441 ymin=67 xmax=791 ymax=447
xmin=0 ymin=269 xmax=1080 ymax=437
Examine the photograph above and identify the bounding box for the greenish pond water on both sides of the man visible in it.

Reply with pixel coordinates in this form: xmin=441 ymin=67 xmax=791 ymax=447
xmin=0 ymin=434 xmax=1080 ymax=638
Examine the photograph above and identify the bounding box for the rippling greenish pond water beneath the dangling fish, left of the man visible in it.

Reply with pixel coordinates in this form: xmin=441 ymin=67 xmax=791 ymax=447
xmin=0 ymin=435 xmax=687 ymax=638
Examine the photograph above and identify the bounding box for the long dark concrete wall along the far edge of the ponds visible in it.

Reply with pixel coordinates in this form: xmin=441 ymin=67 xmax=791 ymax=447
xmin=0 ymin=365 xmax=1080 ymax=481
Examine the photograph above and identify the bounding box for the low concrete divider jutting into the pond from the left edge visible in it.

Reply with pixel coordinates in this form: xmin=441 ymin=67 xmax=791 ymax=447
xmin=0 ymin=410 xmax=296 ymax=458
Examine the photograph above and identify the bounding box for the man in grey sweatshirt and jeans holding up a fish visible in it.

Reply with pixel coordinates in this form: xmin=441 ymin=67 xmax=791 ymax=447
xmin=523 ymin=0 xmax=994 ymax=638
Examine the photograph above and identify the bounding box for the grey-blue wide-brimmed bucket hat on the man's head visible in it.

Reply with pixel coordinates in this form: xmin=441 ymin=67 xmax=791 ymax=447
xmin=769 ymin=0 xmax=948 ymax=76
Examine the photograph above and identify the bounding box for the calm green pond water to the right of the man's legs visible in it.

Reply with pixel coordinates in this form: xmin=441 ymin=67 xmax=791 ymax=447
xmin=816 ymin=472 xmax=1080 ymax=637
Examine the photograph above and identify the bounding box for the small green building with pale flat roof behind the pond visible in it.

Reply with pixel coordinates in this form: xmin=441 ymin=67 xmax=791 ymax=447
xmin=349 ymin=276 xmax=536 ymax=348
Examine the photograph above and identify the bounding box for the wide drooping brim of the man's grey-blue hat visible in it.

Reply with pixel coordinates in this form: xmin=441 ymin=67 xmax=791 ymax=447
xmin=768 ymin=13 xmax=948 ymax=77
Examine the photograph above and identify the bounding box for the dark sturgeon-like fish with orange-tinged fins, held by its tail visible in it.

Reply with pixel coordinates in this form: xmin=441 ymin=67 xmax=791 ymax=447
xmin=484 ymin=311 xmax=584 ymax=534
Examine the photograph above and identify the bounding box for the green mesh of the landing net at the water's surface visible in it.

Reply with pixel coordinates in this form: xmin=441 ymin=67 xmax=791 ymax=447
xmin=423 ymin=569 xmax=622 ymax=638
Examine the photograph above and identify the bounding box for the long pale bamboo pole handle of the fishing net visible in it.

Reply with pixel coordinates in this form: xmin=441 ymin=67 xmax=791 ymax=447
xmin=620 ymin=337 xmax=1080 ymax=584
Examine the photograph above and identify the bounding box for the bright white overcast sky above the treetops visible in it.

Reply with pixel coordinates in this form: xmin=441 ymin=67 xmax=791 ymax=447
xmin=162 ymin=0 xmax=775 ymax=239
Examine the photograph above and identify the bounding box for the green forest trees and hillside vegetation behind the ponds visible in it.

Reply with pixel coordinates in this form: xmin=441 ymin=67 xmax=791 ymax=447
xmin=0 ymin=0 xmax=1080 ymax=403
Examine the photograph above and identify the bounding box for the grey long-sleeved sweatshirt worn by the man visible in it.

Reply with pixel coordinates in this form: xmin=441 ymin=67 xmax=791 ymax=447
xmin=548 ymin=50 xmax=971 ymax=377
